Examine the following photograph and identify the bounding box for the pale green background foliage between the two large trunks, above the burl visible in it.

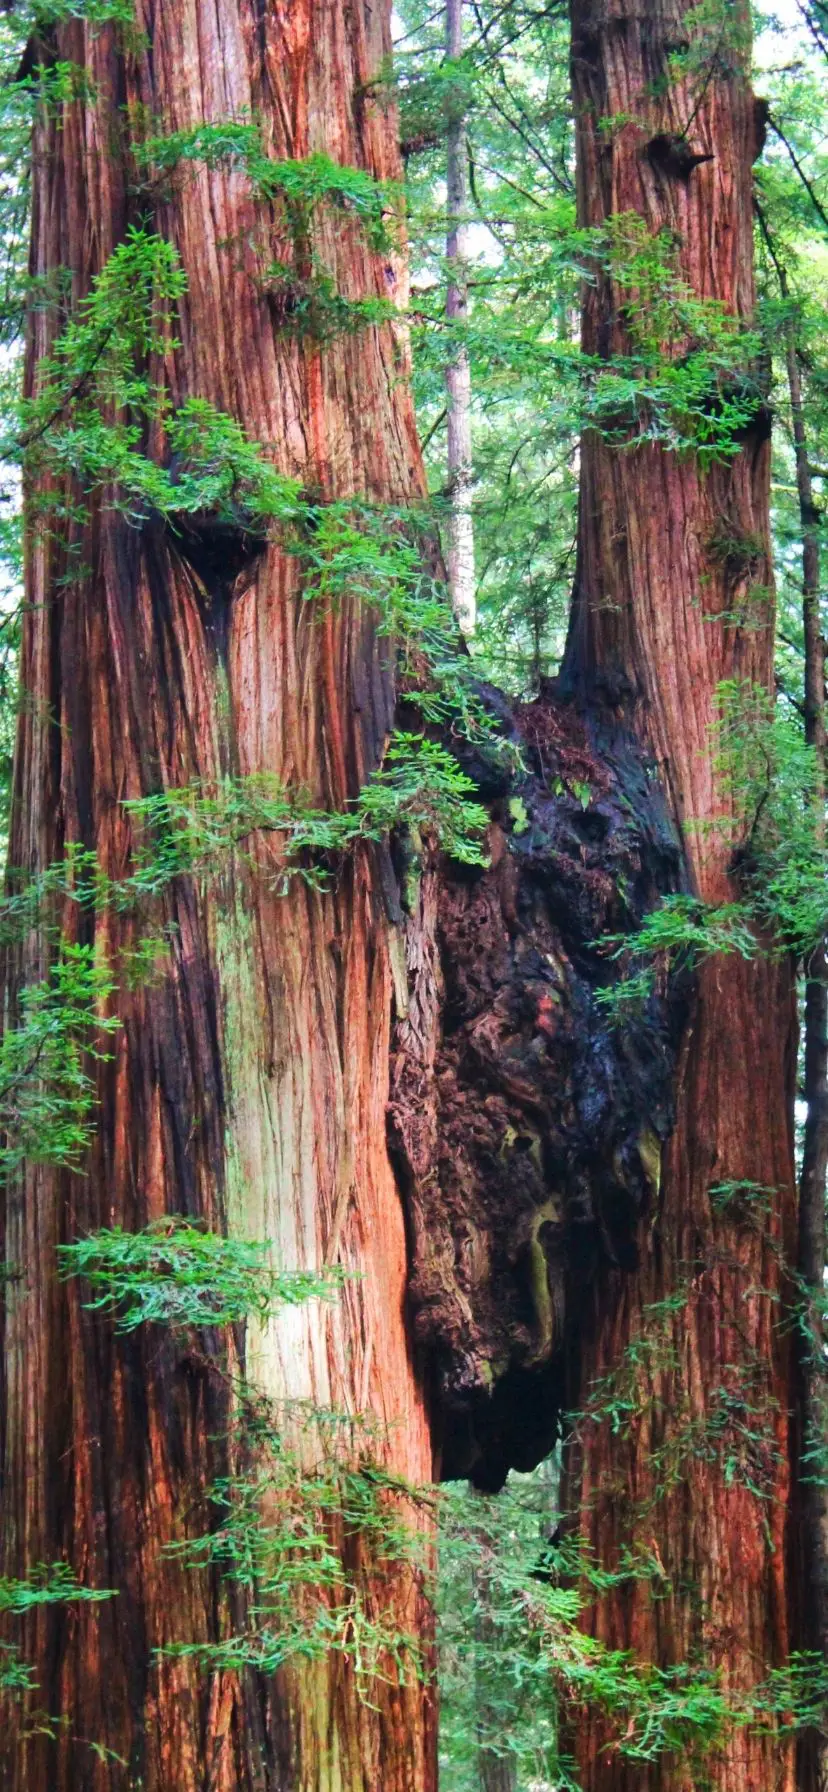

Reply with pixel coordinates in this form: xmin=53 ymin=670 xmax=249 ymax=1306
xmin=392 ymin=0 xmax=579 ymax=690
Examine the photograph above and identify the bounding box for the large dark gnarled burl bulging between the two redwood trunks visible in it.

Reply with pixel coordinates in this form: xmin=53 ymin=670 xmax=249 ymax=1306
xmin=391 ymin=686 xmax=685 ymax=1489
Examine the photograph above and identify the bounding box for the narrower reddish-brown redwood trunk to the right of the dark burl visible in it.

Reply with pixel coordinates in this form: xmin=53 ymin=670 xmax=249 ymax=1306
xmin=563 ymin=0 xmax=796 ymax=1792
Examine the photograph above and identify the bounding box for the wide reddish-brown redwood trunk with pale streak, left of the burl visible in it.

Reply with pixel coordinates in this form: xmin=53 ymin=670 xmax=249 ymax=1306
xmin=0 ymin=0 xmax=434 ymax=1792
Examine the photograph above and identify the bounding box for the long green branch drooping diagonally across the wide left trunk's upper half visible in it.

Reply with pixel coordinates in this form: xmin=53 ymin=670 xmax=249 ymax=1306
xmin=5 ymin=216 xmax=486 ymax=799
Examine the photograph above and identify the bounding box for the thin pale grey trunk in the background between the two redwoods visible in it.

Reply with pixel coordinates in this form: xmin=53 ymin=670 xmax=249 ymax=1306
xmin=446 ymin=0 xmax=477 ymax=634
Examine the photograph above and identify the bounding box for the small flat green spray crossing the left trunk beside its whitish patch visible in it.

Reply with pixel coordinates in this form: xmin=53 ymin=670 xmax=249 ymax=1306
xmin=57 ymin=1213 xmax=342 ymax=1331
